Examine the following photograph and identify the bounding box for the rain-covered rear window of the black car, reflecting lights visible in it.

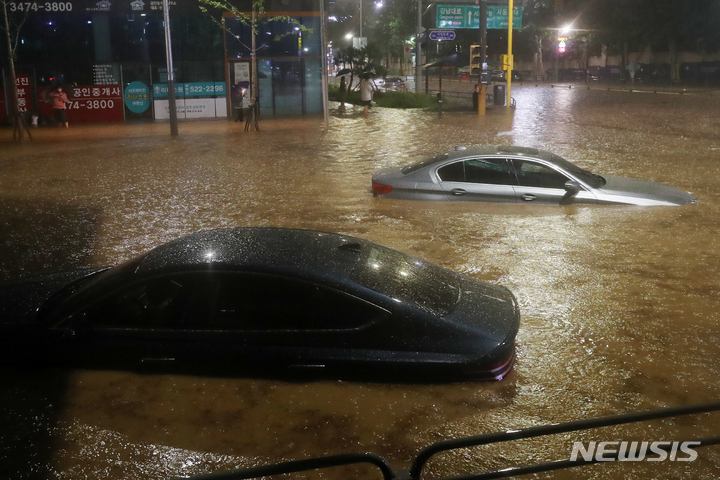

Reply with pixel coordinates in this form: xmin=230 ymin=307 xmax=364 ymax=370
xmin=351 ymin=245 xmax=460 ymax=317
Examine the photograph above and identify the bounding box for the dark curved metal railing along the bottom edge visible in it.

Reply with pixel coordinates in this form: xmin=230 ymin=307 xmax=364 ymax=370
xmin=177 ymin=401 xmax=720 ymax=480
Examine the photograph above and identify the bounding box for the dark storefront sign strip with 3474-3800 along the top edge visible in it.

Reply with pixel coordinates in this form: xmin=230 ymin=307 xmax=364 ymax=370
xmin=7 ymin=0 xmax=200 ymax=15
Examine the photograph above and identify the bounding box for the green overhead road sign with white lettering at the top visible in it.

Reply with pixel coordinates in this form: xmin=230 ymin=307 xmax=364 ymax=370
xmin=435 ymin=5 xmax=522 ymax=30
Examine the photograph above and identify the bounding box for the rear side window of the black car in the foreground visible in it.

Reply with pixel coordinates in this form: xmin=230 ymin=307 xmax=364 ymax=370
xmin=207 ymin=273 xmax=388 ymax=331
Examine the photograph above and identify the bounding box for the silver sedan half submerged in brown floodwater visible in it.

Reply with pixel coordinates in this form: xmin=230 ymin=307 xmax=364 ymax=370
xmin=372 ymin=146 xmax=697 ymax=205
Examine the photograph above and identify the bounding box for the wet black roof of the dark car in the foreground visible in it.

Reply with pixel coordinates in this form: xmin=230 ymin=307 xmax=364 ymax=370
xmin=134 ymin=227 xmax=377 ymax=276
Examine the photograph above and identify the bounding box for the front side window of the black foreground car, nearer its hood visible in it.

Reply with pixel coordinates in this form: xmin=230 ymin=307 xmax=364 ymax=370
xmin=55 ymin=274 xmax=197 ymax=329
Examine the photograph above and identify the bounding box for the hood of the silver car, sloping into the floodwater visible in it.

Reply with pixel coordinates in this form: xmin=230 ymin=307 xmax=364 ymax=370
xmin=597 ymin=175 xmax=697 ymax=205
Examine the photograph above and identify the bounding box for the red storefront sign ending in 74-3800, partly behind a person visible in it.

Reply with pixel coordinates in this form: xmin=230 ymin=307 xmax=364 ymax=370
xmin=40 ymin=85 xmax=123 ymax=123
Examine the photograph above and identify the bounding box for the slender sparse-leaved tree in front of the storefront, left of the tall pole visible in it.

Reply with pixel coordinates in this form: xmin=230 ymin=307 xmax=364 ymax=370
xmin=198 ymin=0 xmax=312 ymax=131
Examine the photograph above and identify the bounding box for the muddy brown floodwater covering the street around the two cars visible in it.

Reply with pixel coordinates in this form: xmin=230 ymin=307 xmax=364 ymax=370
xmin=0 ymin=86 xmax=720 ymax=480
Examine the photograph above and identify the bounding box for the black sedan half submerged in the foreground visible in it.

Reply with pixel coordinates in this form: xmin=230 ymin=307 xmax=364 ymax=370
xmin=0 ymin=228 xmax=520 ymax=380
